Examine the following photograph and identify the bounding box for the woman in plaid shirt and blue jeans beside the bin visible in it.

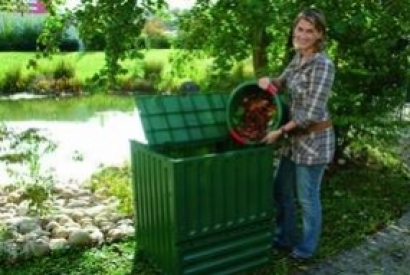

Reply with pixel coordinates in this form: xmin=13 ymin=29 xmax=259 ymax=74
xmin=259 ymin=9 xmax=335 ymax=260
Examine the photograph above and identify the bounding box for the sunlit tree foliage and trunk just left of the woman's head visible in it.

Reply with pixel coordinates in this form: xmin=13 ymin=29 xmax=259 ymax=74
xmin=179 ymin=0 xmax=286 ymax=77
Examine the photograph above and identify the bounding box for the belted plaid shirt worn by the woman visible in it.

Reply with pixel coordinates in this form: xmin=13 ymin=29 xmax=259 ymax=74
xmin=279 ymin=53 xmax=335 ymax=165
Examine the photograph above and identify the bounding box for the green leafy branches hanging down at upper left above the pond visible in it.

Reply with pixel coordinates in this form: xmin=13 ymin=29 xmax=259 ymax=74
xmin=3 ymin=0 xmax=165 ymax=89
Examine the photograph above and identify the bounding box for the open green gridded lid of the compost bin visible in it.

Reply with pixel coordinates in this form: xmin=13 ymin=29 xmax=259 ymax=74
xmin=135 ymin=93 xmax=229 ymax=146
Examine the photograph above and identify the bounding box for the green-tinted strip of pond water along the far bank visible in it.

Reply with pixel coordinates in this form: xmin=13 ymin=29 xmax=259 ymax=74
xmin=0 ymin=94 xmax=135 ymax=121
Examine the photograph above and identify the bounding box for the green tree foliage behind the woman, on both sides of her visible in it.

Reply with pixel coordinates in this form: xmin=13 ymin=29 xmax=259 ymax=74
xmin=179 ymin=0 xmax=410 ymax=163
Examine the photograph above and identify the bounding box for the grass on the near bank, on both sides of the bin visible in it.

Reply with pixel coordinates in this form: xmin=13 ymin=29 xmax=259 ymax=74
xmin=0 ymin=167 xmax=410 ymax=275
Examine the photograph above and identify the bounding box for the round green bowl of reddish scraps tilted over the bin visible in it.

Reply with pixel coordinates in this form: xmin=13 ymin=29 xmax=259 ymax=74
xmin=226 ymin=81 xmax=283 ymax=145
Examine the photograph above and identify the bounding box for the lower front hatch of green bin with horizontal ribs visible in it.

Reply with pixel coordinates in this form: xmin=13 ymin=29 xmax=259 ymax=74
xmin=180 ymin=221 xmax=272 ymax=275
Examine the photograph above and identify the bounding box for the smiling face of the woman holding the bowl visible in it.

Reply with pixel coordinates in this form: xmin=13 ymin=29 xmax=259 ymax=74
xmin=293 ymin=18 xmax=323 ymax=54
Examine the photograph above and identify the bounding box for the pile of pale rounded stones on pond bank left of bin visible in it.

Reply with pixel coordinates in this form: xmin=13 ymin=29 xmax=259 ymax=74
xmin=0 ymin=185 xmax=135 ymax=261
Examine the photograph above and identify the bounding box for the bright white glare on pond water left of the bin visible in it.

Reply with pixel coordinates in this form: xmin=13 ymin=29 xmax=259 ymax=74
xmin=0 ymin=110 xmax=146 ymax=187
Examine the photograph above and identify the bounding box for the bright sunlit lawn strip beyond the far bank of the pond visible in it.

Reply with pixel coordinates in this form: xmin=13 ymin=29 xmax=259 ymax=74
xmin=0 ymin=49 xmax=254 ymax=90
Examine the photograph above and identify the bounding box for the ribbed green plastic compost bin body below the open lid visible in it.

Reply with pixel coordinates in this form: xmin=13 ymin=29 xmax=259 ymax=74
xmin=131 ymin=141 xmax=273 ymax=274
